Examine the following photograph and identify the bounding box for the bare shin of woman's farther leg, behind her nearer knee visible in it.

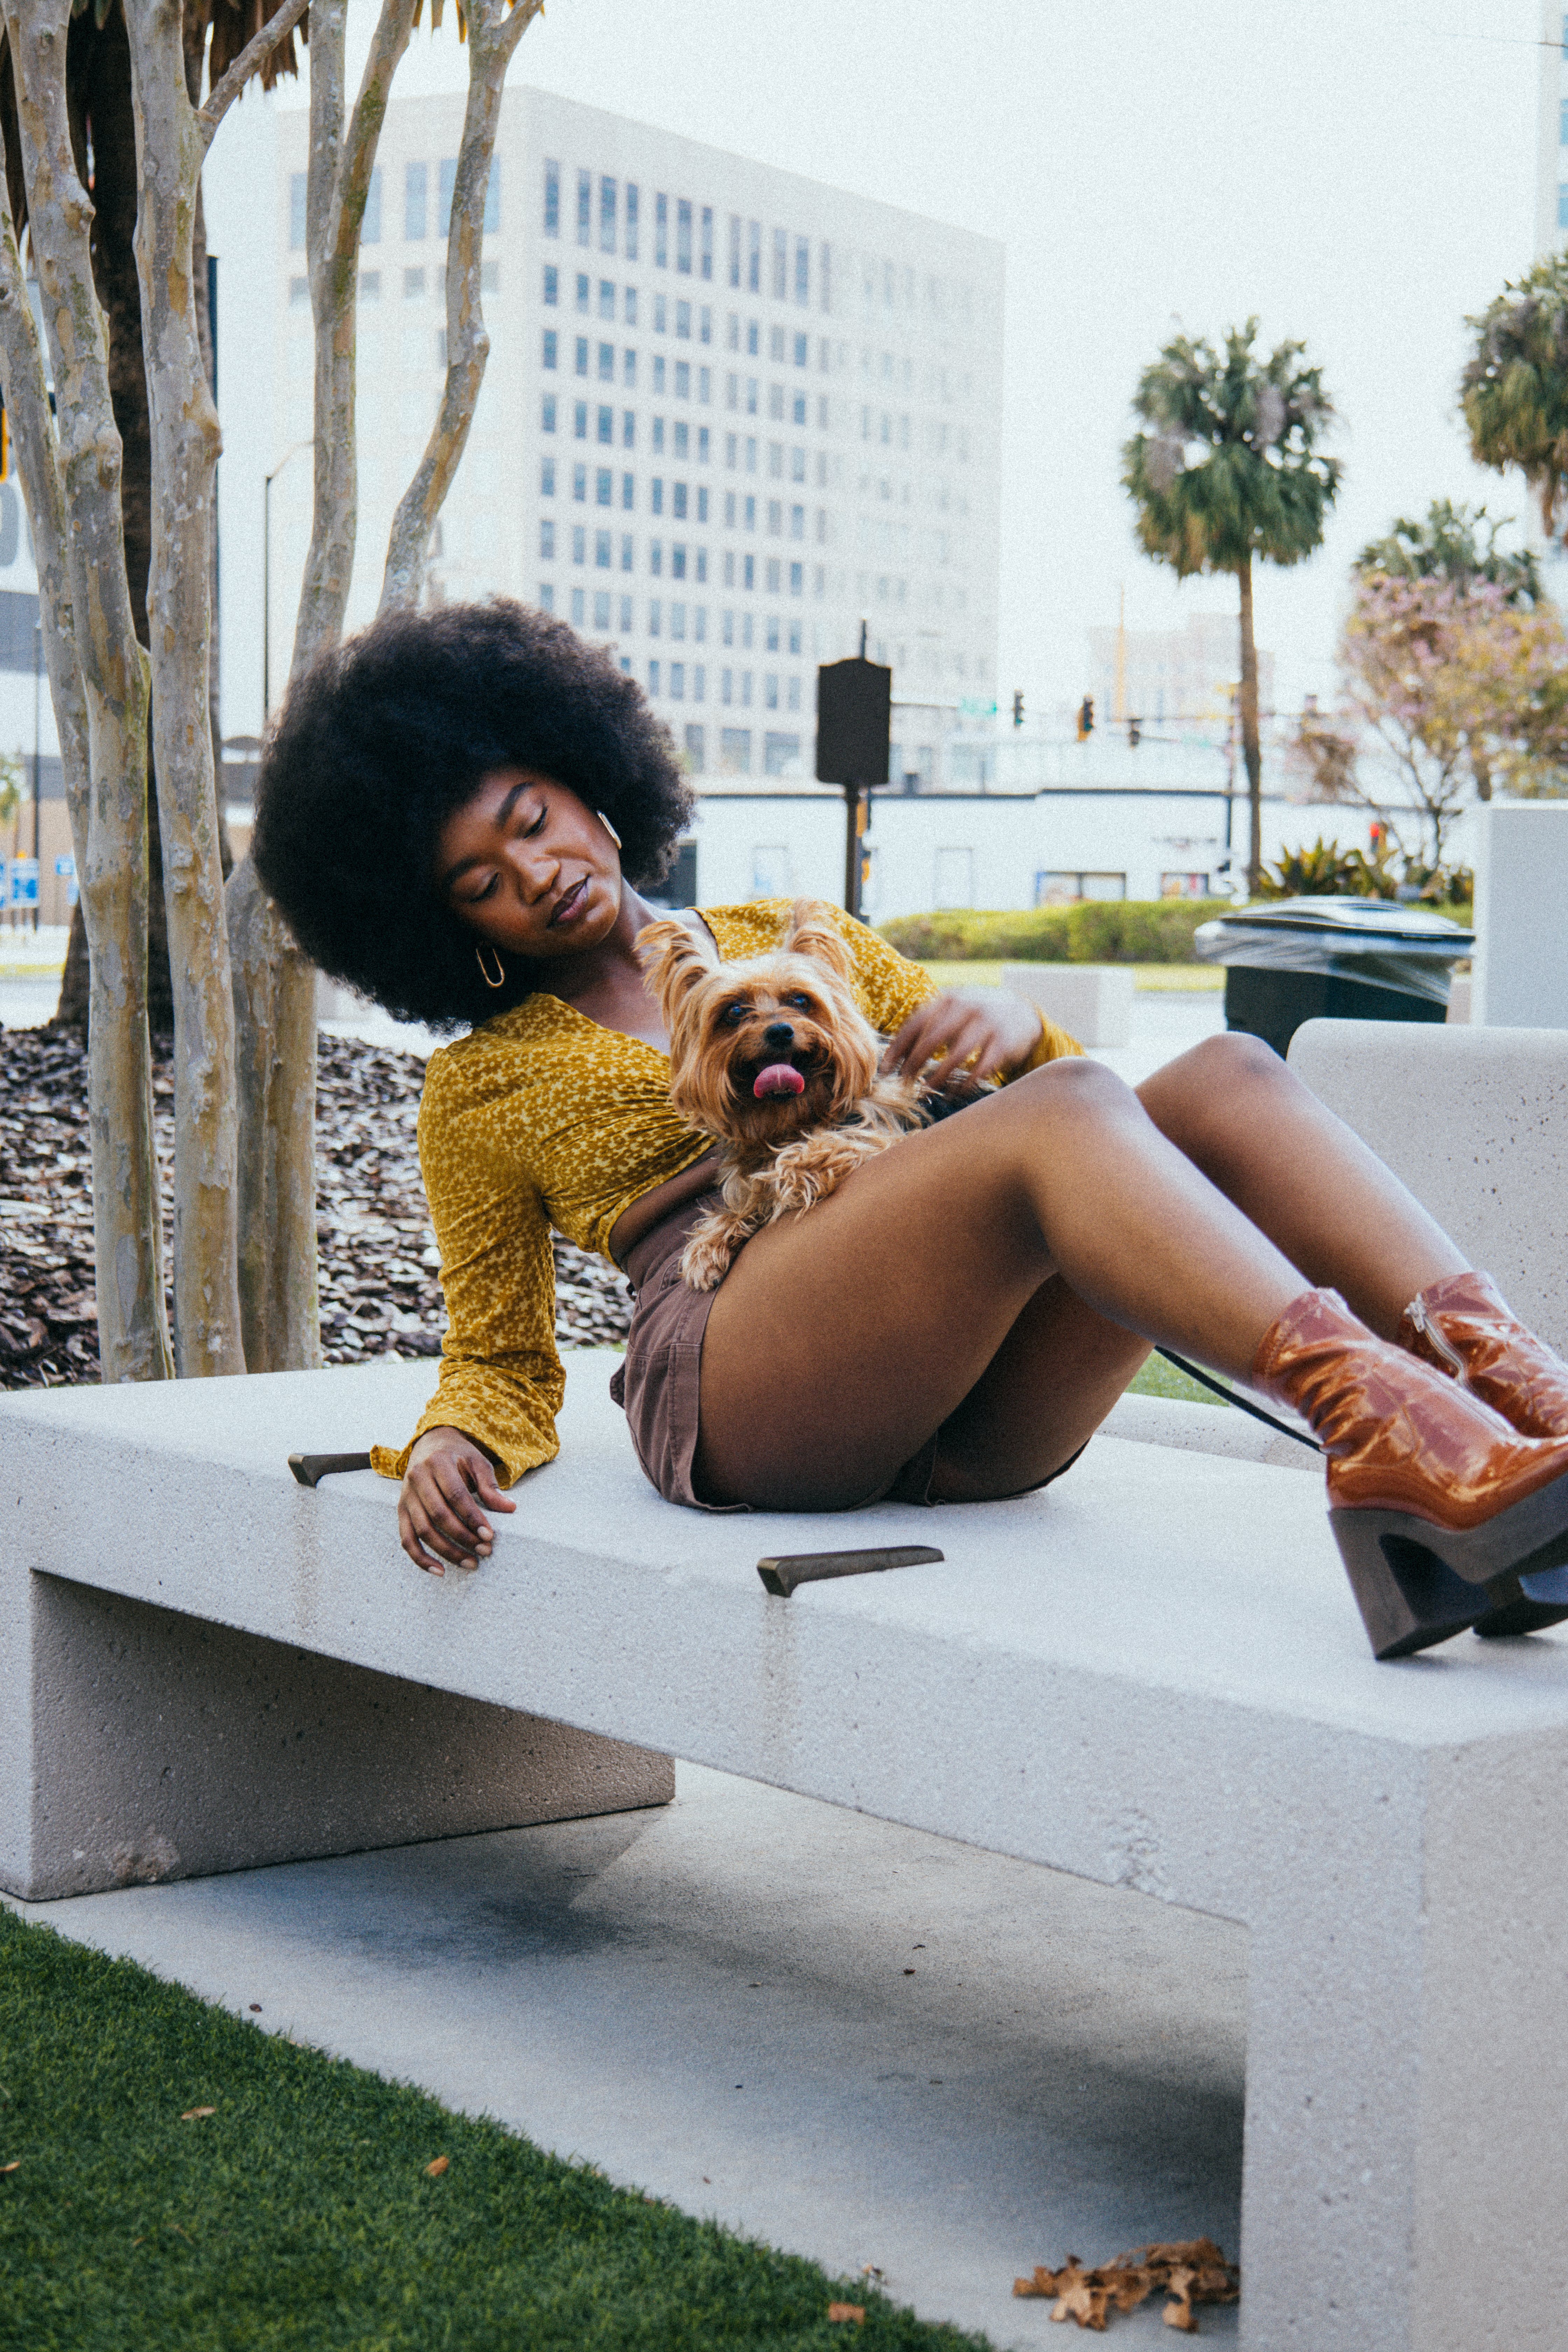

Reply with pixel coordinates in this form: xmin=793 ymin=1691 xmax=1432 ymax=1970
xmin=1138 ymin=1035 xmax=1467 ymax=1338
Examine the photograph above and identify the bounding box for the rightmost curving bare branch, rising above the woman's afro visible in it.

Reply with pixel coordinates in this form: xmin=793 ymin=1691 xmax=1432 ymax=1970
xmin=381 ymin=0 xmax=543 ymax=611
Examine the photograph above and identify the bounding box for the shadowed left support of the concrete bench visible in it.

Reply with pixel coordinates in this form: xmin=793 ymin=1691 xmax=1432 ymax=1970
xmin=0 ymin=1574 xmax=675 ymax=1903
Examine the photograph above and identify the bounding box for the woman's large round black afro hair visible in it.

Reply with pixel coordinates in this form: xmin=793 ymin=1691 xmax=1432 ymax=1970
xmin=252 ymin=597 xmax=691 ymax=1030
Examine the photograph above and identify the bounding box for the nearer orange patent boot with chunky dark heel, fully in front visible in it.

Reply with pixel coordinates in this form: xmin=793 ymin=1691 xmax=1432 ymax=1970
xmin=1253 ymin=1291 xmax=1568 ymax=1658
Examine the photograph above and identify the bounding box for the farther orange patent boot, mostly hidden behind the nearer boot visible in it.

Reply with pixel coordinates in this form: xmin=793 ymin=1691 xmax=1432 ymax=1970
xmin=1396 ymin=1273 xmax=1568 ymax=1642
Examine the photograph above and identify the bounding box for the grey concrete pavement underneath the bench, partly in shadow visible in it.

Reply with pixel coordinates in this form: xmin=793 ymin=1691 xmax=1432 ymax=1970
xmin=6 ymin=1764 xmax=1246 ymax=2352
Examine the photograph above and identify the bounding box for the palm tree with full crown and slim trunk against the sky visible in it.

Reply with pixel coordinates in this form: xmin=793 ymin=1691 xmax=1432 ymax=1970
xmin=1121 ymin=317 xmax=1340 ymax=891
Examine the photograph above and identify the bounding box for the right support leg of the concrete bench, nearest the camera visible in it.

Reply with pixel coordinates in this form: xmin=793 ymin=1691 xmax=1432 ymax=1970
xmin=1241 ymin=1729 xmax=1568 ymax=2352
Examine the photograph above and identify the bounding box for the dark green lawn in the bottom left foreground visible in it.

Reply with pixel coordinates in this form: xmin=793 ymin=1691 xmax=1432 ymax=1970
xmin=0 ymin=1907 xmax=983 ymax=2352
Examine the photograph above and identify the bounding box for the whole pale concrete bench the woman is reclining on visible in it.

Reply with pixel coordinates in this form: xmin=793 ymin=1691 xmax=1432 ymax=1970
xmin=0 ymin=1355 xmax=1568 ymax=2352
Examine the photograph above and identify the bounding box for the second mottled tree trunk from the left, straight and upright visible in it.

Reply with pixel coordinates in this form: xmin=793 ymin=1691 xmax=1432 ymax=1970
xmin=125 ymin=0 xmax=245 ymax=1378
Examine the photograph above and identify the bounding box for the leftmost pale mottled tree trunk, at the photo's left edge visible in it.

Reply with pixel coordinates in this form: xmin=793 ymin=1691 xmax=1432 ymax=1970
xmin=7 ymin=0 xmax=172 ymax=1381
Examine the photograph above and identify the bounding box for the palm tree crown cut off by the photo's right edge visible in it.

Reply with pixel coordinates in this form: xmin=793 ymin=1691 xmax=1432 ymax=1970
xmin=1460 ymin=252 xmax=1568 ymax=539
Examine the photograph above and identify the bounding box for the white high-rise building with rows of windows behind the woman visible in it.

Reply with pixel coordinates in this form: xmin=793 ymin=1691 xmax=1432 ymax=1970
xmin=270 ymin=87 xmax=1004 ymax=776
